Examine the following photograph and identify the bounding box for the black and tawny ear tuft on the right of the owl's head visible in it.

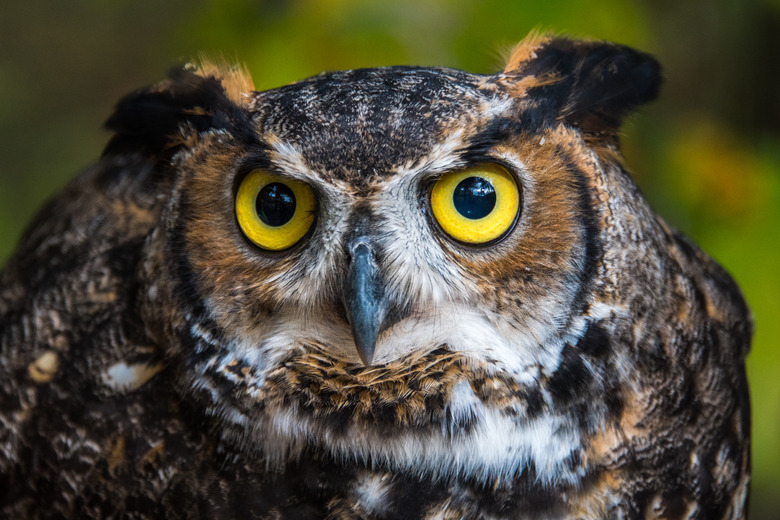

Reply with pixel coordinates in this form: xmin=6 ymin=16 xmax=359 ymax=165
xmin=504 ymin=34 xmax=661 ymax=134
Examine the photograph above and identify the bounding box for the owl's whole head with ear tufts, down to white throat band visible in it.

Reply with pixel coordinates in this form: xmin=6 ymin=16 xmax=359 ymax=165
xmin=104 ymin=35 xmax=661 ymax=482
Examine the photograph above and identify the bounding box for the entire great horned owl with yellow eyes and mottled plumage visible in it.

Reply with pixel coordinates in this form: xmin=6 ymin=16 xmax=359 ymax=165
xmin=0 ymin=36 xmax=752 ymax=519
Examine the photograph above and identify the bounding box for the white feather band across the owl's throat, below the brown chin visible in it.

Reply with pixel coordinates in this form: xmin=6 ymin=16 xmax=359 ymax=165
xmin=257 ymin=398 xmax=582 ymax=484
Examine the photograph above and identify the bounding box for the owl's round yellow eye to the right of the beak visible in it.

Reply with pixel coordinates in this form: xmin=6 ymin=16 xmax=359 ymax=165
xmin=431 ymin=164 xmax=520 ymax=245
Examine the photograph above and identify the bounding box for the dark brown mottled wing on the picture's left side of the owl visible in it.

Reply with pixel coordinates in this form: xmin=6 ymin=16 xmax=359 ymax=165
xmin=0 ymin=157 xmax=181 ymax=518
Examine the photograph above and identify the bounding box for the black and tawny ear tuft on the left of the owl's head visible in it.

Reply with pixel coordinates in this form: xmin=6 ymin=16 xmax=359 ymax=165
xmin=103 ymin=60 xmax=253 ymax=160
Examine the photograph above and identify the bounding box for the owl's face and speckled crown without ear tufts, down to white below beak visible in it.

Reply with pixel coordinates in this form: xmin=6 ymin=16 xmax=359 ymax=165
xmin=170 ymin=68 xmax=588 ymax=368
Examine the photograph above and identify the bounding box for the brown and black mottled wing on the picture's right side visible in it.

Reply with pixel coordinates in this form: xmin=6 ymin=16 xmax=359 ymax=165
xmin=592 ymin=226 xmax=753 ymax=518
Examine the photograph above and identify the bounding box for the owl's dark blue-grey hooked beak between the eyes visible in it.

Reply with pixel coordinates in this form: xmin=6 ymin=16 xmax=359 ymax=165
xmin=344 ymin=238 xmax=387 ymax=366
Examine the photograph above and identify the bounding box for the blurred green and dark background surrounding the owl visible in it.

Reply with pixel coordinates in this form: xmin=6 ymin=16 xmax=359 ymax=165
xmin=0 ymin=0 xmax=780 ymax=519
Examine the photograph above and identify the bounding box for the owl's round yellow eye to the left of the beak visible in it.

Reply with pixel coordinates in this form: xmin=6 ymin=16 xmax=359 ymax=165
xmin=236 ymin=170 xmax=316 ymax=251
